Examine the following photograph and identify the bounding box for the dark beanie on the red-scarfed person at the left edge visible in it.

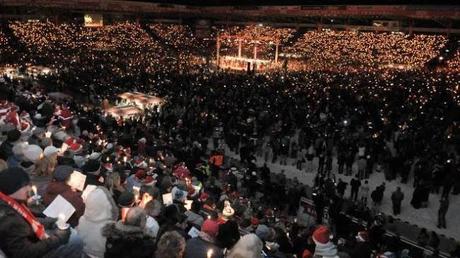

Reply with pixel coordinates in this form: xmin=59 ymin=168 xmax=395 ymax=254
xmin=0 ymin=167 xmax=30 ymax=195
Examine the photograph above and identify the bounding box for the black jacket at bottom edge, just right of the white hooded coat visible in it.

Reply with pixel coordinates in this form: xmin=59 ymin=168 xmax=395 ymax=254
xmin=102 ymin=221 xmax=155 ymax=258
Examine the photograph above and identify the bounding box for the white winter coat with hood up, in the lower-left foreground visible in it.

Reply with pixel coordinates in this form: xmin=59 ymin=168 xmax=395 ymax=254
xmin=76 ymin=187 xmax=118 ymax=258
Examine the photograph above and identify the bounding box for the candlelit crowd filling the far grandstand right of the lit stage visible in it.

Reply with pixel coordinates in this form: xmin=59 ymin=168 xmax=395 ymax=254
xmin=289 ymin=29 xmax=447 ymax=70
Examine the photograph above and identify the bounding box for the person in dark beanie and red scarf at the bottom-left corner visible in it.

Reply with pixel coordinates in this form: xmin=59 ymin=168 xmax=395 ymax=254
xmin=0 ymin=168 xmax=81 ymax=258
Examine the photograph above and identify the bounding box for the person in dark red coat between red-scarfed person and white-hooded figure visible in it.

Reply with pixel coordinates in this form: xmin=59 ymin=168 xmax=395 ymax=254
xmin=43 ymin=166 xmax=85 ymax=227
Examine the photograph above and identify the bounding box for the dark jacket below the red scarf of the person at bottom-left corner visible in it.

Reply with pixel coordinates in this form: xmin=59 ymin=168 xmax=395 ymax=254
xmin=0 ymin=201 xmax=61 ymax=258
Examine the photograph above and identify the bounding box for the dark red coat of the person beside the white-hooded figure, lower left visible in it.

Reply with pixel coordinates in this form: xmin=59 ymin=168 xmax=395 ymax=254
xmin=43 ymin=181 xmax=85 ymax=227
